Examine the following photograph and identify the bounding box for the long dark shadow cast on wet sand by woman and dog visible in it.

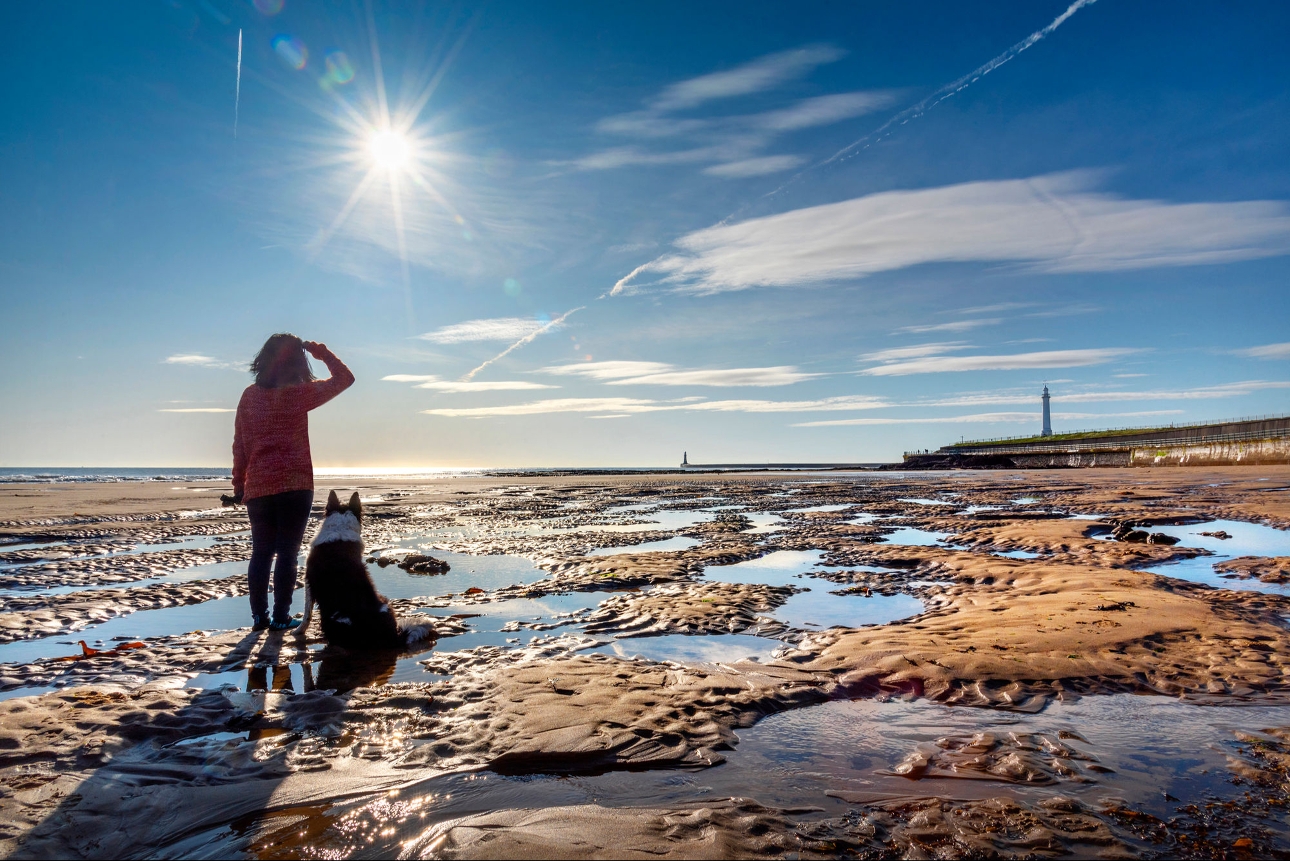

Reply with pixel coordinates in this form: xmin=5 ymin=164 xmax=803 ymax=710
xmin=10 ymin=633 xmax=428 ymax=858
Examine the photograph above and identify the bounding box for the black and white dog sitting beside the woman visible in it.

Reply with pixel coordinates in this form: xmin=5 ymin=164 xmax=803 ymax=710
xmin=295 ymin=491 xmax=435 ymax=649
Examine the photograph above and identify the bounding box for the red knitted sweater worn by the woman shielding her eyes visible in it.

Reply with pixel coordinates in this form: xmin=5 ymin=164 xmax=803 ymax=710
xmin=233 ymin=352 xmax=353 ymax=501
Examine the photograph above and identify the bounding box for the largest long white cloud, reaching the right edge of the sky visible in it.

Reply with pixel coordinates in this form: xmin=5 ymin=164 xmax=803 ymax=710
xmin=610 ymin=173 xmax=1290 ymax=294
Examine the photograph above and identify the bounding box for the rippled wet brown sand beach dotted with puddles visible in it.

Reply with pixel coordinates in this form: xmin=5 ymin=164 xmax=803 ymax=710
xmin=0 ymin=467 xmax=1290 ymax=857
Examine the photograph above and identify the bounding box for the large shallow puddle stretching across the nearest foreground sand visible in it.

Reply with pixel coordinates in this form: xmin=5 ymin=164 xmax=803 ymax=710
xmin=179 ymin=691 xmax=1290 ymax=857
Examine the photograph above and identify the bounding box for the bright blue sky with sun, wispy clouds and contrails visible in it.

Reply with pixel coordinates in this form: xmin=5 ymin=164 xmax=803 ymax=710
xmin=0 ymin=0 xmax=1290 ymax=466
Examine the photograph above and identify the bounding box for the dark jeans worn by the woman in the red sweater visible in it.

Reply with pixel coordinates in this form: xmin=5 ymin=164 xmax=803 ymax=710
xmin=246 ymin=491 xmax=313 ymax=622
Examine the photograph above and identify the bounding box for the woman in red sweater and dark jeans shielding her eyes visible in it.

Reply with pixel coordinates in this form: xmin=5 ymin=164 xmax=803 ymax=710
xmin=233 ymin=334 xmax=353 ymax=631
